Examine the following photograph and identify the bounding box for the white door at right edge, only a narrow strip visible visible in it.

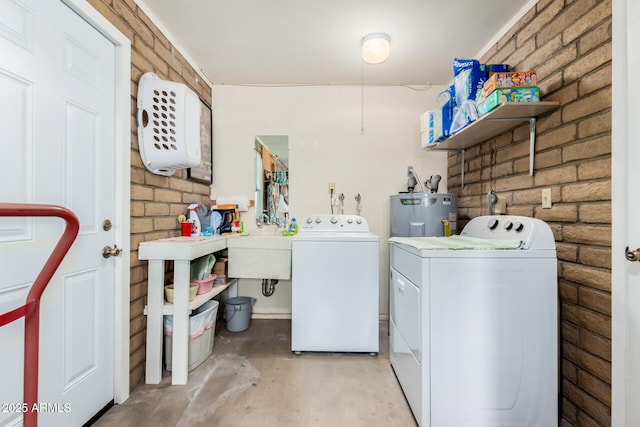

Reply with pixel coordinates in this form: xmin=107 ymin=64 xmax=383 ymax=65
xmin=612 ymin=0 xmax=640 ymax=426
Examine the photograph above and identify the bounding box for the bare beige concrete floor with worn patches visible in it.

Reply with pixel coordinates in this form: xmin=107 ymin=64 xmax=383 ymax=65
xmin=94 ymin=319 xmax=416 ymax=427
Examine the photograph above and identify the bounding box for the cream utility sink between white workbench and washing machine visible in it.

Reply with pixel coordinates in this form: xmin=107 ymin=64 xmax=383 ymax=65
xmin=227 ymin=230 xmax=291 ymax=280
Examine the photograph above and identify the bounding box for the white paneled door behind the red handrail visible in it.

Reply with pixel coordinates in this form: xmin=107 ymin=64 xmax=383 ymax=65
xmin=0 ymin=0 xmax=115 ymax=425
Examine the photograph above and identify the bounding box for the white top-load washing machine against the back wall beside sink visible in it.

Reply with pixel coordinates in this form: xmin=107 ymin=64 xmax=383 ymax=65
xmin=291 ymin=214 xmax=380 ymax=353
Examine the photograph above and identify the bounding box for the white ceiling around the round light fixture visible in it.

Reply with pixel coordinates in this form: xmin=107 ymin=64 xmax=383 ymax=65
xmin=137 ymin=0 xmax=536 ymax=86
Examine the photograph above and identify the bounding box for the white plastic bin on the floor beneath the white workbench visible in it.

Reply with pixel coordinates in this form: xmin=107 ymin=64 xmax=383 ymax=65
xmin=164 ymin=300 xmax=218 ymax=371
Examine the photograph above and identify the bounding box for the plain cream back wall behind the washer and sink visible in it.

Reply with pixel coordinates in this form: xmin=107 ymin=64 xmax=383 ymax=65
xmin=211 ymin=86 xmax=447 ymax=317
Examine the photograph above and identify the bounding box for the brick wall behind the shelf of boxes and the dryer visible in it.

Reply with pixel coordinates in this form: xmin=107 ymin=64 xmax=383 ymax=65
xmin=448 ymin=0 xmax=611 ymax=426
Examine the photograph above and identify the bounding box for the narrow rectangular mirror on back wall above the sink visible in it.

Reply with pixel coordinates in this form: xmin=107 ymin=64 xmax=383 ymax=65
xmin=255 ymin=135 xmax=289 ymax=224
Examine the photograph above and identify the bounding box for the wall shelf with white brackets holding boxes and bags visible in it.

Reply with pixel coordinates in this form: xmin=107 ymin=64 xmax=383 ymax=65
xmin=428 ymin=101 xmax=560 ymax=187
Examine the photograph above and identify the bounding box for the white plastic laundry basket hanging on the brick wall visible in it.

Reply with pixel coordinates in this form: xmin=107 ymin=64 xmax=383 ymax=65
xmin=137 ymin=73 xmax=202 ymax=176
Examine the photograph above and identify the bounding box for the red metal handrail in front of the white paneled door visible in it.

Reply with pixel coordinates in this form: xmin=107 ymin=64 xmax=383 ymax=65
xmin=0 ymin=203 xmax=80 ymax=427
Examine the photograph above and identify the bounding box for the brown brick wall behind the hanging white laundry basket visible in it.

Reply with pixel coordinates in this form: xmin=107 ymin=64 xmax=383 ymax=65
xmin=88 ymin=0 xmax=211 ymax=389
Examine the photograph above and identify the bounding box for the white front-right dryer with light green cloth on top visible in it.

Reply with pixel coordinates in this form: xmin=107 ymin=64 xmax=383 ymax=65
xmin=389 ymin=216 xmax=558 ymax=427
